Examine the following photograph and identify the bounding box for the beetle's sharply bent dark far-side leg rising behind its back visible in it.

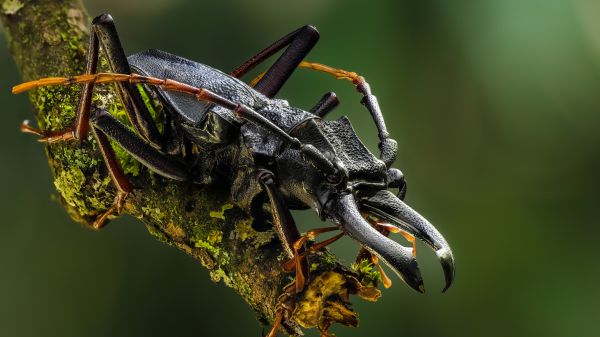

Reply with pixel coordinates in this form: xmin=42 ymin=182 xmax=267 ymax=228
xmin=230 ymin=26 xmax=319 ymax=98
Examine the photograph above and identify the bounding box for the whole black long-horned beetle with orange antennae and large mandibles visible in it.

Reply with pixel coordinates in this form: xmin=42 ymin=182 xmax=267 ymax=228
xmin=13 ymin=14 xmax=454 ymax=336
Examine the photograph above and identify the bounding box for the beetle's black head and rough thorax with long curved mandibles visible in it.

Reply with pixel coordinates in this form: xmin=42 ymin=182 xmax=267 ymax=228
xmin=278 ymin=117 xmax=454 ymax=292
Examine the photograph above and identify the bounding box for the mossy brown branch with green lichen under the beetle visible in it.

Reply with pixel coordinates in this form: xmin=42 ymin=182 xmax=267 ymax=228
xmin=0 ymin=0 xmax=379 ymax=333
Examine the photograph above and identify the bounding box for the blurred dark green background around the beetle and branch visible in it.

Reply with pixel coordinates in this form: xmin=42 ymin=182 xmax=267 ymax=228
xmin=0 ymin=0 xmax=600 ymax=337
